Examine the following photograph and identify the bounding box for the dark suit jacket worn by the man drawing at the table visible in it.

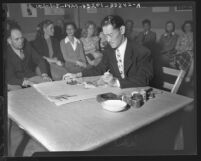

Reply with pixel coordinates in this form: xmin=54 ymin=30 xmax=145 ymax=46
xmin=82 ymin=40 xmax=153 ymax=88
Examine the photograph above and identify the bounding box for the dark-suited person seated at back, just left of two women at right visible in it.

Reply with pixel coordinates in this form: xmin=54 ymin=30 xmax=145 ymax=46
xmin=136 ymin=19 xmax=156 ymax=54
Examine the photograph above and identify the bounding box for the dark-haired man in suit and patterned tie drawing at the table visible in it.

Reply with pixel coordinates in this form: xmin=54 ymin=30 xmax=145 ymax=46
xmin=63 ymin=15 xmax=153 ymax=88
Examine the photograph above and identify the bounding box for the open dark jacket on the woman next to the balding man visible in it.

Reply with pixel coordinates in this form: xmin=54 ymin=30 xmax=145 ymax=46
xmin=32 ymin=36 xmax=64 ymax=62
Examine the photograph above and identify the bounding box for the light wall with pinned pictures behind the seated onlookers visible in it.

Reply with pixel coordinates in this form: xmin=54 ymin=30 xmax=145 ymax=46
xmin=8 ymin=3 xmax=192 ymax=40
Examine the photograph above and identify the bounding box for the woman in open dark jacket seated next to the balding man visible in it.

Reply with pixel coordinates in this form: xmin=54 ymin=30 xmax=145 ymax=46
xmin=32 ymin=20 xmax=66 ymax=80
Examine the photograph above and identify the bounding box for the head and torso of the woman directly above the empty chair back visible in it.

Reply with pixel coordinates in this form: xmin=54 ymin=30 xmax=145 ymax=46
xmin=159 ymin=21 xmax=178 ymax=67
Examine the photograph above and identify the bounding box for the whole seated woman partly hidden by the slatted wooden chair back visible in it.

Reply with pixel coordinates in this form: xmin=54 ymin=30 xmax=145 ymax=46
xmin=151 ymin=21 xmax=178 ymax=89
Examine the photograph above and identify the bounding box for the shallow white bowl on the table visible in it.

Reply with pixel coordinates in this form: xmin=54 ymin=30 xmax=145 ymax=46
xmin=101 ymin=100 xmax=127 ymax=112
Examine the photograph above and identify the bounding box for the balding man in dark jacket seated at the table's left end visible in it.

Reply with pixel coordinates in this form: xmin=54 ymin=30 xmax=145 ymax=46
xmin=6 ymin=26 xmax=51 ymax=90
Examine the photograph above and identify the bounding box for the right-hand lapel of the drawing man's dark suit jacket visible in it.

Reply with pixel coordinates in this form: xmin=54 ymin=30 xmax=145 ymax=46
xmin=124 ymin=41 xmax=132 ymax=74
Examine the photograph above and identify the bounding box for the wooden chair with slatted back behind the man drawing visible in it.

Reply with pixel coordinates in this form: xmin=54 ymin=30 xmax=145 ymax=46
xmin=162 ymin=67 xmax=186 ymax=150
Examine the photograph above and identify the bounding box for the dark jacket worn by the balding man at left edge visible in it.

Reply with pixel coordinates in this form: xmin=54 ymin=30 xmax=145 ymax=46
xmin=6 ymin=41 xmax=48 ymax=85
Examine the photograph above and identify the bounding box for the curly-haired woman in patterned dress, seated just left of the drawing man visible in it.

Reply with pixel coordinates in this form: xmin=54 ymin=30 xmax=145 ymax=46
xmin=80 ymin=21 xmax=102 ymax=67
